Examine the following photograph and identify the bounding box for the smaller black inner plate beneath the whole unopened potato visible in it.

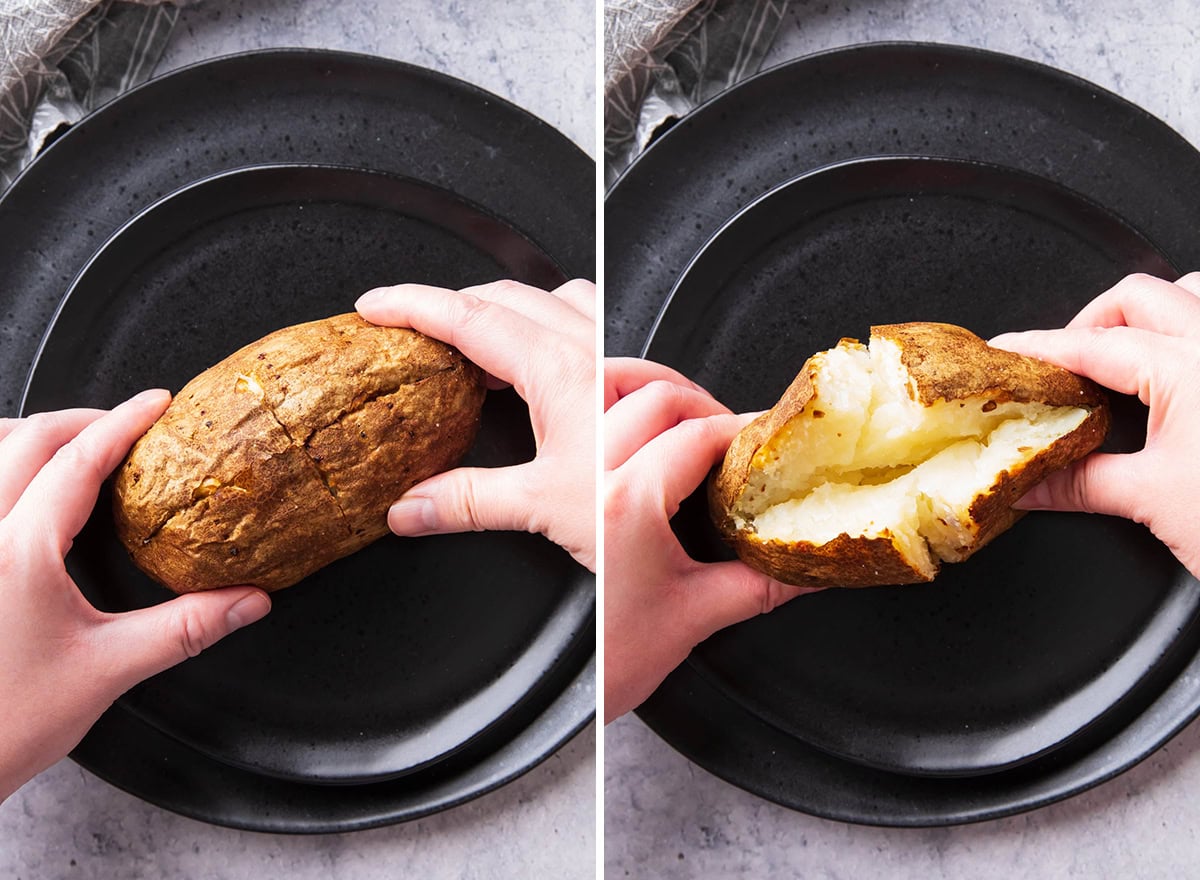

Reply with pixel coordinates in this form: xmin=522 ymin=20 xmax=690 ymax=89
xmin=23 ymin=166 xmax=593 ymax=783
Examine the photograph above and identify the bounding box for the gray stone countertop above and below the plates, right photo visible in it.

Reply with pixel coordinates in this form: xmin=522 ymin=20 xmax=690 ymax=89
xmin=605 ymin=0 xmax=1200 ymax=880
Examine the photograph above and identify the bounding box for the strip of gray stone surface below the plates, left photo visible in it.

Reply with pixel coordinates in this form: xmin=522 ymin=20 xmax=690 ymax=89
xmin=0 ymin=726 xmax=595 ymax=880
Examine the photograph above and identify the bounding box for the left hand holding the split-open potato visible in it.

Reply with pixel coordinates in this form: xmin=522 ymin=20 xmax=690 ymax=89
xmin=604 ymin=358 xmax=816 ymax=723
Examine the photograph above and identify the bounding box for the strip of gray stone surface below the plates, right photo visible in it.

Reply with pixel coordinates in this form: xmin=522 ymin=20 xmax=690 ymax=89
xmin=605 ymin=717 xmax=1200 ymax=880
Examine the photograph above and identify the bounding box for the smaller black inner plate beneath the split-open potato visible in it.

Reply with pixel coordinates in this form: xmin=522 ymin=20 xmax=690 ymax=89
xmin=646 ymin=158 xmax=1200 ymax=776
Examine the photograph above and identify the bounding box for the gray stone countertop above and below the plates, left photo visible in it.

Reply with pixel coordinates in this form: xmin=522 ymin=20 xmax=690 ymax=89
xmin=0 ymin=0 xmax=596 ymax=880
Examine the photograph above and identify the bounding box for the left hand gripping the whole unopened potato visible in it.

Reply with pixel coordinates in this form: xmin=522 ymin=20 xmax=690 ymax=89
xmin=0 ymin=391 xmax=270 ymax=801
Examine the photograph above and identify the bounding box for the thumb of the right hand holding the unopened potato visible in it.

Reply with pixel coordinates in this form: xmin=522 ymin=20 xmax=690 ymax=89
xmin=388 ymin=465 xmax=534 ymax=538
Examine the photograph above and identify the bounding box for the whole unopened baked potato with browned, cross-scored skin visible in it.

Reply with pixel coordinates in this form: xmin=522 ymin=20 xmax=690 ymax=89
xmin=113 ymin=313 xmax=486 ymax=593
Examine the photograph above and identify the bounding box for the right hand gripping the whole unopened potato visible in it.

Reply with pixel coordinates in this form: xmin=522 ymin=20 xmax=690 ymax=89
xmin=355 ymin=281 xmax=596 ymax=571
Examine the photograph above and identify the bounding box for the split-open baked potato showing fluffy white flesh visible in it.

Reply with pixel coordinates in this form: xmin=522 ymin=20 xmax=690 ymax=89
xmin=709 ymin=323 xmax=1110 ymax=587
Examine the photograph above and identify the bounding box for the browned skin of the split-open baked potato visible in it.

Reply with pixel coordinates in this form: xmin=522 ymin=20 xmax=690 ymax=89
xmin=708 ymin=322 xmax=1111 ymax=587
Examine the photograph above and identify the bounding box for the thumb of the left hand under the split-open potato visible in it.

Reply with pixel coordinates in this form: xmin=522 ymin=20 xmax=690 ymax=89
xmin=686 ymin=561 xmax=820 ymax=645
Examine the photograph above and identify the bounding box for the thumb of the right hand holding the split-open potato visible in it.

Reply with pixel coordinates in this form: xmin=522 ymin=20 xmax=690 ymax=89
xmin=1013 ymin=453 xmax=1144 ymax=519
